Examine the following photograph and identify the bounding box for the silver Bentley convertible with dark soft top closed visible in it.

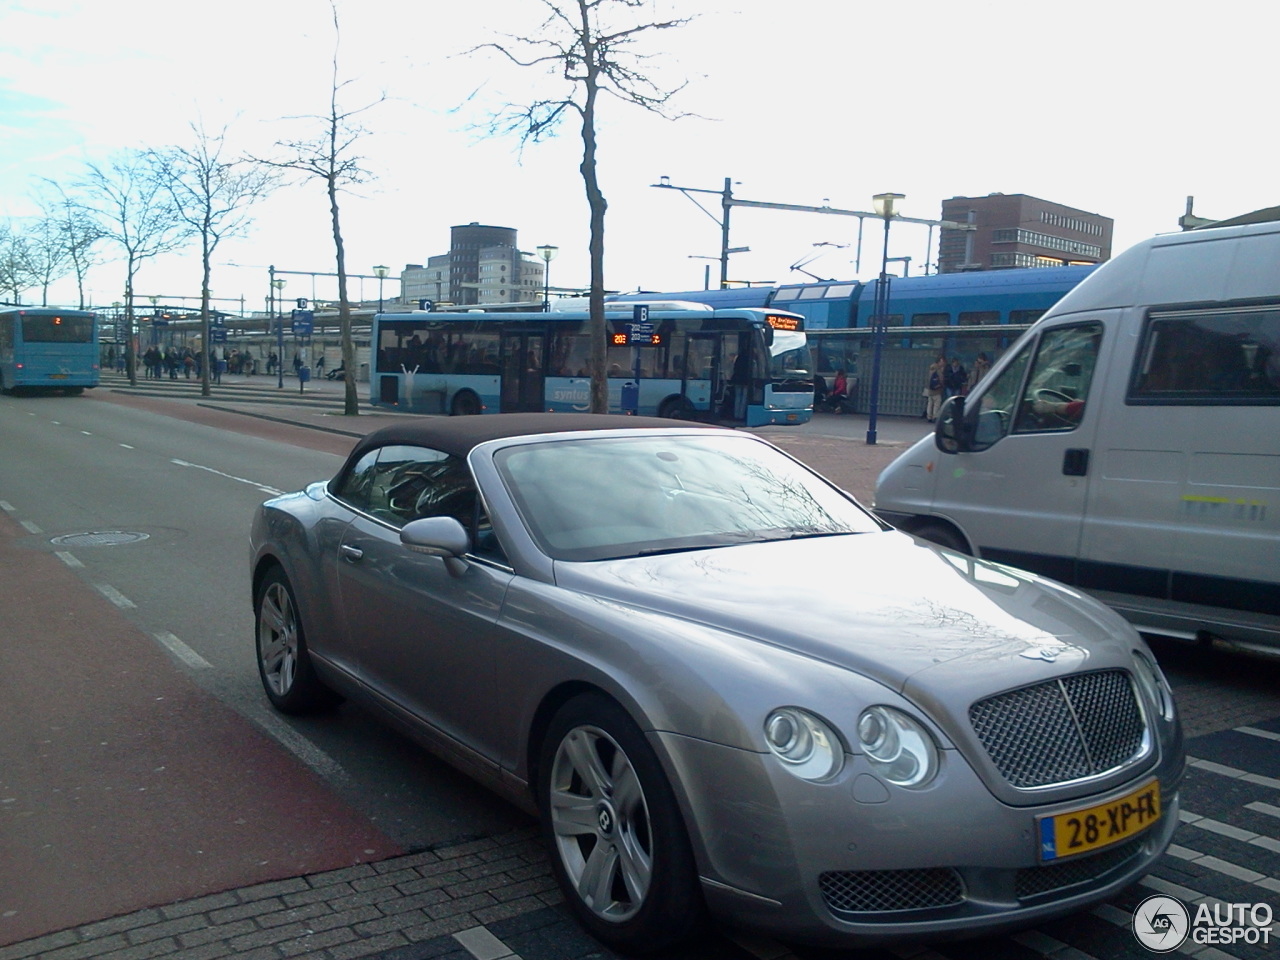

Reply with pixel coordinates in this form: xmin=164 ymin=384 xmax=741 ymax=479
xmin=251 ymin=413 xmax=1184 ymax=952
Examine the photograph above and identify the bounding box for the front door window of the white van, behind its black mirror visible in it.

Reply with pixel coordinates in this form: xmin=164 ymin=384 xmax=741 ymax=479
xmin=1014 ymin=323 xmax=1102 ymax=434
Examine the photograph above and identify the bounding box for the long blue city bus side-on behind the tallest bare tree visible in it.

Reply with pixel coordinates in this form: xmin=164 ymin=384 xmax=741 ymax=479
xmin=369 ymin=303 xmax=813 ymax=426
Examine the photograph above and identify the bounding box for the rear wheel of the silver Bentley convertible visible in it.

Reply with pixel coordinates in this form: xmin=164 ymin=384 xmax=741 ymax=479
xmin=253 ymin=567 xmax=340 ymax=714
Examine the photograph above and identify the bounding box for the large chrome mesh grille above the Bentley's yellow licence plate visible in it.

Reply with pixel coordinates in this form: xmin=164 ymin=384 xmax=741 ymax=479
xmin=969 ymin=669 xmax=1146 ymax=787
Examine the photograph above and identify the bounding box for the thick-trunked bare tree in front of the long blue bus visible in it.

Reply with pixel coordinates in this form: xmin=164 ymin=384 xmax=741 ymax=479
xmin=476 ymin=0 xmax=691 ymax=413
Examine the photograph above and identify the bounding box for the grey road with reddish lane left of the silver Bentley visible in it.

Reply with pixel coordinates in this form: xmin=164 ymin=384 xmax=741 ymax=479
xmin=0 ymin=394 xmax=527 ymax=942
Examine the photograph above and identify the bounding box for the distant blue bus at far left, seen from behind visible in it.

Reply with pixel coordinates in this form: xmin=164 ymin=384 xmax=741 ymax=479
xmin=0 ymin=307 xmax=101 ymax=394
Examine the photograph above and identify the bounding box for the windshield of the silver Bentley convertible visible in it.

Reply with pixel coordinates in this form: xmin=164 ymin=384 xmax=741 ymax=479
xmin=495 ymin=431 xmax=881 ymax=561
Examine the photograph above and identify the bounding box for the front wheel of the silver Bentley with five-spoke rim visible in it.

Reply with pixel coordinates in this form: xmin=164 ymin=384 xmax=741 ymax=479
xmin=538 ymin=694 xmax=704 ymax=954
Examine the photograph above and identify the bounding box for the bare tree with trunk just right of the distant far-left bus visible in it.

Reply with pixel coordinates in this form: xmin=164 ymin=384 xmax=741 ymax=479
xmin=77 ymin=150 xmax=191 ymax=384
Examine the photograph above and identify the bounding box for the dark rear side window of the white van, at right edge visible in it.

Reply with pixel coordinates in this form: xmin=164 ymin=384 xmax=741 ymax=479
xmin=1128 ymin=306 xmax=1280 ymax=406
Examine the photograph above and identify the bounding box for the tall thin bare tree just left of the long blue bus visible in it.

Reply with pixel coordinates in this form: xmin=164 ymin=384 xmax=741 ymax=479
xmin=253 ymin=0 xmax=385 ymax=416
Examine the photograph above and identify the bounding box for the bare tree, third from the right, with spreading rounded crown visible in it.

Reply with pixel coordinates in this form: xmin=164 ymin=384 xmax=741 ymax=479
xmin=154 ymin=124 xmax=276 ymax=397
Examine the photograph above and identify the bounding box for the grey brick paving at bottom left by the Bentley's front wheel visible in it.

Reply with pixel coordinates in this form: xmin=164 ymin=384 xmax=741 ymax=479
xmin=0 ymin=829 xmax=613 ymax=960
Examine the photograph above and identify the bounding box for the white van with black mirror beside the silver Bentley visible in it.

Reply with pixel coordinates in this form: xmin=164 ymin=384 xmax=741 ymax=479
xmin=876 ymin=223 xmax=1280 ymax=648
